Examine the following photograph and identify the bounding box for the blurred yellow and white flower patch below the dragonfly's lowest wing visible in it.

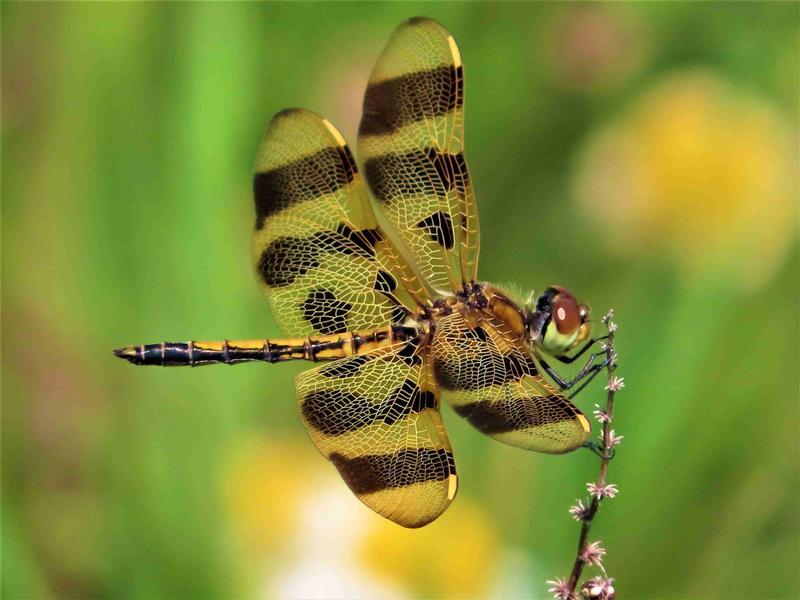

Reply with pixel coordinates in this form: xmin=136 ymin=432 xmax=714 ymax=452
xmin=223 ymin=438 xmax=506 ymax=598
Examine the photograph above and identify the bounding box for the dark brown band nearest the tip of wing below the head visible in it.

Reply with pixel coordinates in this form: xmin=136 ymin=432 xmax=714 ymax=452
xmin=454 ymin=396 xmax=575 ymax=434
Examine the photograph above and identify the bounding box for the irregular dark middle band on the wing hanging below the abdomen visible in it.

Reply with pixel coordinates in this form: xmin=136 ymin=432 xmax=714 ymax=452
xmin=302 ymin=379 xmax=436 ymax=435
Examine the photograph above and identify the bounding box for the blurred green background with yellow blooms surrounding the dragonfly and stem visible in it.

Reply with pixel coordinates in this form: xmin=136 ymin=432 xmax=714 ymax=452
xmin=2 ymin=2 xmax=800 ymax=598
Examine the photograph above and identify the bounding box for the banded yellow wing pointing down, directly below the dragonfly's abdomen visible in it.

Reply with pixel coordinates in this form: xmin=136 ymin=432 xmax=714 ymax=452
xmin=296 ymin=341 xmax=457 ymax=527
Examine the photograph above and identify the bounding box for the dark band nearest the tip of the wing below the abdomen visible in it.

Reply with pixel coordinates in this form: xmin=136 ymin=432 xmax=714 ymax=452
xmin=330 ymin=448 xmax=455 ymax=494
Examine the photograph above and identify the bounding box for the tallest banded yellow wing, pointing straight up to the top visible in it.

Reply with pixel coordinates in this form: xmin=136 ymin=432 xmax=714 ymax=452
xmin=358 ymin=18 xmax=479 ymax=291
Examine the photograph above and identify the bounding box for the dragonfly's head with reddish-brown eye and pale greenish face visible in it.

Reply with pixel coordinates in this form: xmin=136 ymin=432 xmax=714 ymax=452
xmin=528 ymin=286 xmax=592 ymax=355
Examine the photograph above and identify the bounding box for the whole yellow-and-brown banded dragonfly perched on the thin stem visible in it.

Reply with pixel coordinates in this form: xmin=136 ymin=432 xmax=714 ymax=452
xmin=114 ymin=17 xmax=607 ymax=528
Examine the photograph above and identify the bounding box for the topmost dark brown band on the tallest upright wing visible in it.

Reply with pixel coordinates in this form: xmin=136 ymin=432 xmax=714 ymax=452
xmin=358 ymin=65 xmax=464 ymax=135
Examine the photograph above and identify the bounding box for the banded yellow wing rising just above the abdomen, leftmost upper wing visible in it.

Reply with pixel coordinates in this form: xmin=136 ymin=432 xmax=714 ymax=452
xmin=253 ymin=109 xmax=424 ymax=335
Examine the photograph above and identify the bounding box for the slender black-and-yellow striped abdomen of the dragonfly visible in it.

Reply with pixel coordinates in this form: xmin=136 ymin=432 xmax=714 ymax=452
xmin=114 ymin=325 xmax=419 ymax=367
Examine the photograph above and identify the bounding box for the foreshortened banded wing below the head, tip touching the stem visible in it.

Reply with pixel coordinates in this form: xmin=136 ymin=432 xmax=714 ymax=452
xmin=431 ymin=313 xmax=590 ymax=454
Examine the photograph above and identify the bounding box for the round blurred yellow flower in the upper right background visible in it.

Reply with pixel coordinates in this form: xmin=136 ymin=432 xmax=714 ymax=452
xmin=576 ymin=71 xmax=798 ymax=287
